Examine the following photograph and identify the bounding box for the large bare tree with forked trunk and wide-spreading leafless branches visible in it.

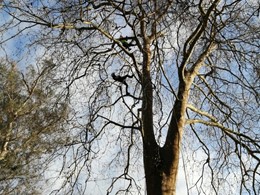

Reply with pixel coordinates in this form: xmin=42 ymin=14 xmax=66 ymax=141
xmin=1 ymin=0 xmax=260 ymax=195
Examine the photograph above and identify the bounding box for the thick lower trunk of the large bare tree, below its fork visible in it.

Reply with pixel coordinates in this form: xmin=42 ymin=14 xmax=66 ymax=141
xmin=144 ymin=125 xmax=181 ymax=195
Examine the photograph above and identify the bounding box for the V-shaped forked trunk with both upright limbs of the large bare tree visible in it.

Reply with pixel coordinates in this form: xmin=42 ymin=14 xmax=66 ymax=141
xmin=142 ymin=31 xmax=192 ymax=195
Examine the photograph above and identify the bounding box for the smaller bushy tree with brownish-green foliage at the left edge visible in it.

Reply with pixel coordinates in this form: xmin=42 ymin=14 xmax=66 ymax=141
xmin=0 ymin=59 xmax=68 ymax=194
